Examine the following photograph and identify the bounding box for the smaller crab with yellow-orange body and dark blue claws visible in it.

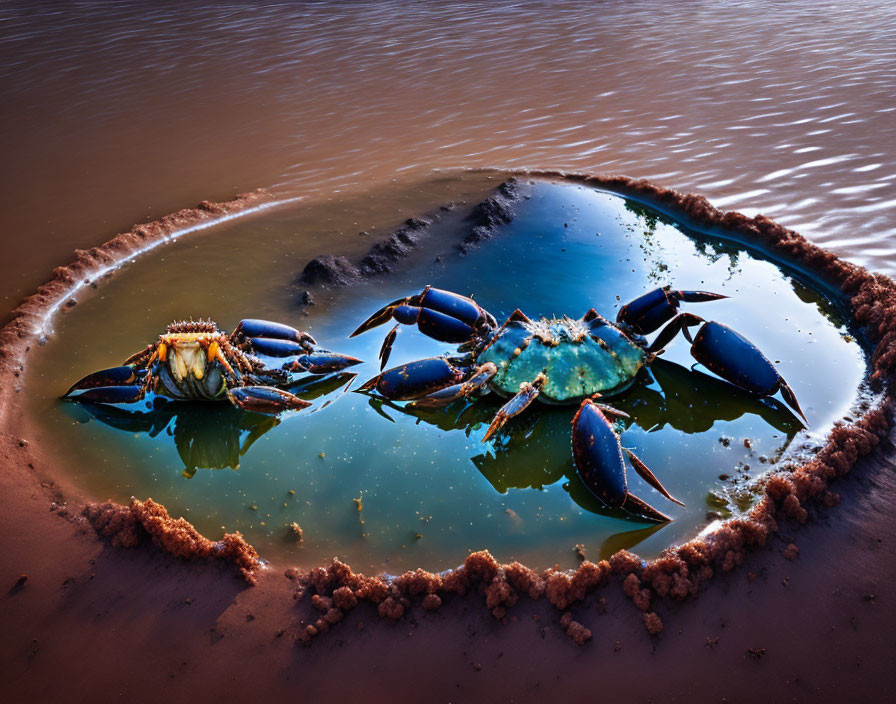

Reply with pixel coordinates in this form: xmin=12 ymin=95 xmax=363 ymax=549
xmin=63 ymin=318 xmax=361 ymax=415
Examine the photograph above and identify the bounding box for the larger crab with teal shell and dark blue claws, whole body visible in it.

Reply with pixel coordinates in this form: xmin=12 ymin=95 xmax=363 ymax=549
xmin=352 ymin=286 xmax=805 ymax=522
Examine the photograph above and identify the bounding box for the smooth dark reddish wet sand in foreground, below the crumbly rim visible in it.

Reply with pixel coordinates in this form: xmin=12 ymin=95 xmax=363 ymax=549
xmin=0 ymin=447 xmax=896 ymax=702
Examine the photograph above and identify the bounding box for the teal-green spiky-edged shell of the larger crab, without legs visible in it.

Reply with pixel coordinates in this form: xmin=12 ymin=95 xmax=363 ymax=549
xmin=477 ymin=318 xmax=647 ymax=404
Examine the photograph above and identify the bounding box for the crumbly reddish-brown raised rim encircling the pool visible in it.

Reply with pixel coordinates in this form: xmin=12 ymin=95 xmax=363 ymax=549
xmin=0 ymin=172 xmax=896 ymax=643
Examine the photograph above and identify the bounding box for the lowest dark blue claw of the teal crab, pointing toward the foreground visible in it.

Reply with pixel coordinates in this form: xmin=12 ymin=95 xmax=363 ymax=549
xmin=572 ymin=399 xmax=684 ymax=523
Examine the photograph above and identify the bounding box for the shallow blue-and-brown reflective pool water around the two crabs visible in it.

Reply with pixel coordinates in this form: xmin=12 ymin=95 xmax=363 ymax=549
xmin=27 ymin=173 xmax=865 ymax=572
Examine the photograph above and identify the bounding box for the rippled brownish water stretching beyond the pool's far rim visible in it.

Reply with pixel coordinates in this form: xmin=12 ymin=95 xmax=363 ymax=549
xmin=0 ymin=0 xmax=896 ymax=310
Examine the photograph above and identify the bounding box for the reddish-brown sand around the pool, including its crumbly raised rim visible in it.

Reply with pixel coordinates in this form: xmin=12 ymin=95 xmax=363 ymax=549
xmin=0 ymin=176 xmax=896 ymax=701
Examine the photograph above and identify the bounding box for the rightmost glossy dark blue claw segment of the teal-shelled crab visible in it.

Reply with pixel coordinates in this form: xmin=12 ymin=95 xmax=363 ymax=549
xmin=691 ymin=320 xmax=808 ymax=423
